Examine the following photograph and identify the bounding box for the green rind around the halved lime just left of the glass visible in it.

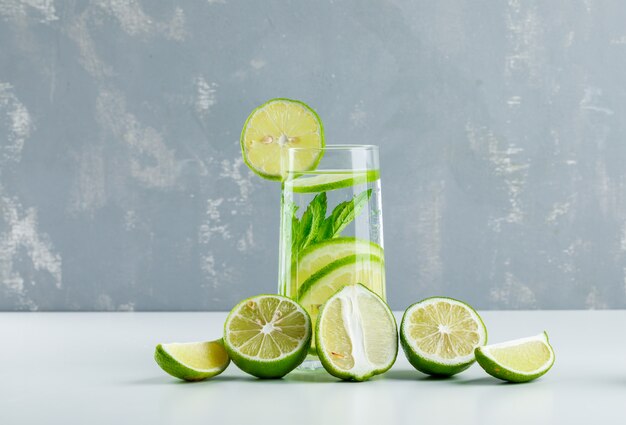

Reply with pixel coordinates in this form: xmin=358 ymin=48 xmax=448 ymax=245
xmin=223 ymin=294 xmax=313 ymax=379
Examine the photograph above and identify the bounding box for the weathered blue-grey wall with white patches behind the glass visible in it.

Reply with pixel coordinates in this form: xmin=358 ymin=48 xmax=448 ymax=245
xmin=0 ymin=0 xmax=626 ymax=310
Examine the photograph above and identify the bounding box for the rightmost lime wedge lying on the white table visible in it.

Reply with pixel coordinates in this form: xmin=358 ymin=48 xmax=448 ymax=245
xmin=476 ymin=332 xmax=554 ymax=382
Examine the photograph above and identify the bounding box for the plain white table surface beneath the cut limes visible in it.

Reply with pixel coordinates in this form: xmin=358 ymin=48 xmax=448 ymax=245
xmin=0 ymin=311 xmax=626 ymax=425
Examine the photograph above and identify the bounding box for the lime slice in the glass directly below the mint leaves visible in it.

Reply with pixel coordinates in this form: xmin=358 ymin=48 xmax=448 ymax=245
xmin=290 ymin=237 xmax=384 ymax=295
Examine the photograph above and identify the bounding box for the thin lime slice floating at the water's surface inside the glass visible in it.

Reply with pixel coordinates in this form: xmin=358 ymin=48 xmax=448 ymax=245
xmin=285 ymin=170 xmax=380 ymax=193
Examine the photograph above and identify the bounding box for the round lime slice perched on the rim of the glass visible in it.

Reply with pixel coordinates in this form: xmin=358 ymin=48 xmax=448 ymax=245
xmin=241 ymin=98 xmax=324 ymax=180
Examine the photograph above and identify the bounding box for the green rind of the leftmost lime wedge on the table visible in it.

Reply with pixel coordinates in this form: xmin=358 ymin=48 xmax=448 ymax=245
xmin=154 ymin=339 xmax=230 ymax=382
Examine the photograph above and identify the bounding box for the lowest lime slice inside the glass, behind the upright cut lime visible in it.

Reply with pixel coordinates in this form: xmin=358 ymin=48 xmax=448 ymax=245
xmin=298 ymin=254 xmax=385 ymax=352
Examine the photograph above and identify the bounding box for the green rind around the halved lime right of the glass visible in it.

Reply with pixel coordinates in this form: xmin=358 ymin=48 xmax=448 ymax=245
xmin=400 ymin=297 xmax=487 ymax=377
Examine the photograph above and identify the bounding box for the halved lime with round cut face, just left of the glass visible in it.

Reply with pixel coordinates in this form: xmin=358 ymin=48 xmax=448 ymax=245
xmin=224 ymin=295 xmax=312 ymax=378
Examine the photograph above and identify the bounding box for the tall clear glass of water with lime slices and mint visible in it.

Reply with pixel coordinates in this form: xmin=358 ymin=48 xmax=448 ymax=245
xmin=278 ymin=145 xmax=385 ymax=369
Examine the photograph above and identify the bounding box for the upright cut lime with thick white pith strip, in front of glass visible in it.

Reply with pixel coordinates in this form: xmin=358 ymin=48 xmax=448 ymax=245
xmin=315 ymin=284 xmax=398 ymax=381
